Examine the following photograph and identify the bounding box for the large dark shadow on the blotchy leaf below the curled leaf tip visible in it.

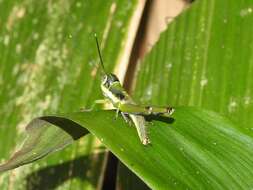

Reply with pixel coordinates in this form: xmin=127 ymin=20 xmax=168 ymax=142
xmin=26 ymin=153 xmax=104 ymax=190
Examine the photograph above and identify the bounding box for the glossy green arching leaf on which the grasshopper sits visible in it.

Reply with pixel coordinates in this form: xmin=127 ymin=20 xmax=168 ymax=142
xmin=2 ymin=107 xmax=253 ymax=189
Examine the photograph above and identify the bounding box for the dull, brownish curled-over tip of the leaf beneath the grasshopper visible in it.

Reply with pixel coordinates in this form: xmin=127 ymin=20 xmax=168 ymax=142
xmin=0 ymin=117 xmax=88 ymax=172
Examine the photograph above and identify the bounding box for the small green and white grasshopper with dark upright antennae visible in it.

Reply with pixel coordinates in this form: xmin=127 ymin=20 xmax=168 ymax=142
xmin=94 ymin=34 xmax=174 ymax=145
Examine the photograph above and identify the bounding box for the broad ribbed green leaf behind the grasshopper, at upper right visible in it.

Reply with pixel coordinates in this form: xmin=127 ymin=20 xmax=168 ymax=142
xmin=133 ymin=0 xmax=253 ymax=131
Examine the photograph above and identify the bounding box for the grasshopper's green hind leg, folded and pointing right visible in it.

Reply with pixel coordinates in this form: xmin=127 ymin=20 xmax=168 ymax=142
xmin=118 ymin=103 xmax=174 ymax=116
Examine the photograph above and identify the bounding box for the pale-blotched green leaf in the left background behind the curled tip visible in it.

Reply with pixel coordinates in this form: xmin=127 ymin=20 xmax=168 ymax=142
xmin=0 ymin=0 xmax=140 ymax=189
